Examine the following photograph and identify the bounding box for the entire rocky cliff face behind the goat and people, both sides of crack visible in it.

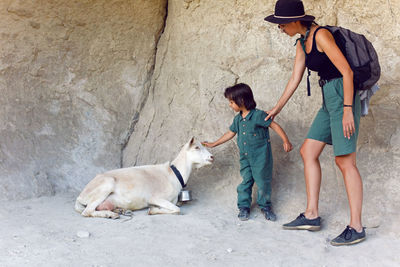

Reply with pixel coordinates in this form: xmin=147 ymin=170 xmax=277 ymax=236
xmin=0 ymin=0 xmax=400 ymax=234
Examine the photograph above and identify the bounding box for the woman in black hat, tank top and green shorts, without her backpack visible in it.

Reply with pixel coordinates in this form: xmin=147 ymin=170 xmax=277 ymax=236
xmin=265 ymin=0 xmax=365 ymax=245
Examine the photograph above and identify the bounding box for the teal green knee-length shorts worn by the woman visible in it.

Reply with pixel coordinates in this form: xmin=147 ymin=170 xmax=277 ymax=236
xmin=307 ymin=78 xmax=361 ymax=156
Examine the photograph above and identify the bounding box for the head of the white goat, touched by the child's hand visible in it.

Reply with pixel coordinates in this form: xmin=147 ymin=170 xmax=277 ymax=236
xmin=185 ymin=137 xmax=214 ymax=168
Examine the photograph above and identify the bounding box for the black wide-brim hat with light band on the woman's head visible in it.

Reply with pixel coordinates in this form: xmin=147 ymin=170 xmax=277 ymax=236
xmin=264 ymin=0 xmax=315 ymax=24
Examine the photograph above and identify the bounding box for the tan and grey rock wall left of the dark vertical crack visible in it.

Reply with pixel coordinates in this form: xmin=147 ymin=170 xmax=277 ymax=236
xmin=0 ymin=0 xmax=166 ymax=199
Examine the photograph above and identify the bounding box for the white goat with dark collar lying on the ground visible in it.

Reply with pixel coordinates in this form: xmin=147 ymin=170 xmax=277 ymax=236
xmin=75 ymin=138 xmax=213 ymax=219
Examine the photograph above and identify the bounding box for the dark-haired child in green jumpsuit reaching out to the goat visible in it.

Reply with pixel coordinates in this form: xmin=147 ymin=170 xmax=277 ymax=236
xmin=202 ymin=83 xmax=292 ymax=221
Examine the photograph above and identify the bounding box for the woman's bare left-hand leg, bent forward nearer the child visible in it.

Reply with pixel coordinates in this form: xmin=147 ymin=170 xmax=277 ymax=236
xmin=300 ymin=139 xmax=326 ymax=219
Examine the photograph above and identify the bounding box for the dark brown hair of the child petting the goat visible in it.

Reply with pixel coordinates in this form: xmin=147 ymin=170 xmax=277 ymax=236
xmin=224 ymin=83 xmax=257 ymax=110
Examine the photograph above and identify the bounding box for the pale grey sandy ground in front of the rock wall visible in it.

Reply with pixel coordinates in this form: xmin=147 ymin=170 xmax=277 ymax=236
xmin=0 ymin=194 xmax=400 ymax=266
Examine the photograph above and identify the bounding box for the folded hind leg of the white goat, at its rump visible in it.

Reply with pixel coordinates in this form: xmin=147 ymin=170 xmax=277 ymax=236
xmin=79 ymin=176 xmax=119 ymax=219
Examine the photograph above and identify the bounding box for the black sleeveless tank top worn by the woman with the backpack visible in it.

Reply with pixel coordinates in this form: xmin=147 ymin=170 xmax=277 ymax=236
xmin=306 ymin=27 xmax=342 ymax=80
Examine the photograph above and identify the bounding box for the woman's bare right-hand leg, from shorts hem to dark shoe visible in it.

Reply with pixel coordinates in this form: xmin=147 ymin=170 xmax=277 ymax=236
xmin=335 ymin=152 xmax=363 ymax=232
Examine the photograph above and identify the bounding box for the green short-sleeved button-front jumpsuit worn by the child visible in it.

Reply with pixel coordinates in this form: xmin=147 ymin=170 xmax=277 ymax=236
xmin=229 ymin=109 xmax=273 ymax=208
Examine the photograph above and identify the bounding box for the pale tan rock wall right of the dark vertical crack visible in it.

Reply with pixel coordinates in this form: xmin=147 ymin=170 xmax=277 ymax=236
xmin=124 ymin=0 xmax=400 ymax=234
